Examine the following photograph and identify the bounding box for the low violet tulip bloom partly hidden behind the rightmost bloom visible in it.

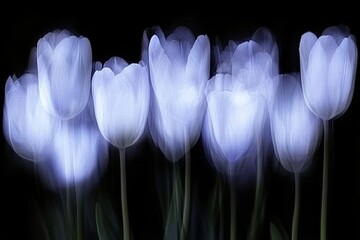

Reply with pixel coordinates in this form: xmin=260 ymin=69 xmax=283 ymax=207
xmin=270 ymin=74 xmax=322 ymax=173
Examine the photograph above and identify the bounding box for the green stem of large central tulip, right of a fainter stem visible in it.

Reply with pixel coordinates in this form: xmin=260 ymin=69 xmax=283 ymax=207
xmin=180 ymin=150 xmax=191 ymax=240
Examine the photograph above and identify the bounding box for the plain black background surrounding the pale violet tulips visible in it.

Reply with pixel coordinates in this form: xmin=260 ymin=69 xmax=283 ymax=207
xmin=0 ymin=6 xmax=360 ymax=239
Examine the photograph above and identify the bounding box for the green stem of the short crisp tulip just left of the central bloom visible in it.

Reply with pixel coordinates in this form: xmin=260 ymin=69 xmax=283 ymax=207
xmin=119 ymin=148 xmax=130 ymax=240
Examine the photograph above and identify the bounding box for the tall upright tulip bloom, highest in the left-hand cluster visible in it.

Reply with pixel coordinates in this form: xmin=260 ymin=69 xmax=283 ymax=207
xmin=37 ymin=30 xmax=92 ymax=119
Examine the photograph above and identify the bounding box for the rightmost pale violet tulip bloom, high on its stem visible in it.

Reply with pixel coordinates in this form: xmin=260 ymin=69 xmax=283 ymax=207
xmin=299 ymin=27 xmax=357 ymax=120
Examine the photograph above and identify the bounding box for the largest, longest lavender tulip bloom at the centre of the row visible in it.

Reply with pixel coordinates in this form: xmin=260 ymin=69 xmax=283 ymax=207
xmin=148 ymin=27 xmax=210 ymax=161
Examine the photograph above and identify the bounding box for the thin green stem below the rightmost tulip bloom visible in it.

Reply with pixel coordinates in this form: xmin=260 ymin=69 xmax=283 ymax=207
xmin=320 ymin=120 xmax=333 ymax=240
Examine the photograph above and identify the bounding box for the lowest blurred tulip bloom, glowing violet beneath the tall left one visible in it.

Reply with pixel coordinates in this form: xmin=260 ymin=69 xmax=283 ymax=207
xmin=40 ymin=97 xmax=108 ymax=188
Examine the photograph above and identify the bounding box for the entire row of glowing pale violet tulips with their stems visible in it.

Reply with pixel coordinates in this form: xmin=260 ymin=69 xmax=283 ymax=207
xmin=3 ymin=26 xmax=357 ymax=239
